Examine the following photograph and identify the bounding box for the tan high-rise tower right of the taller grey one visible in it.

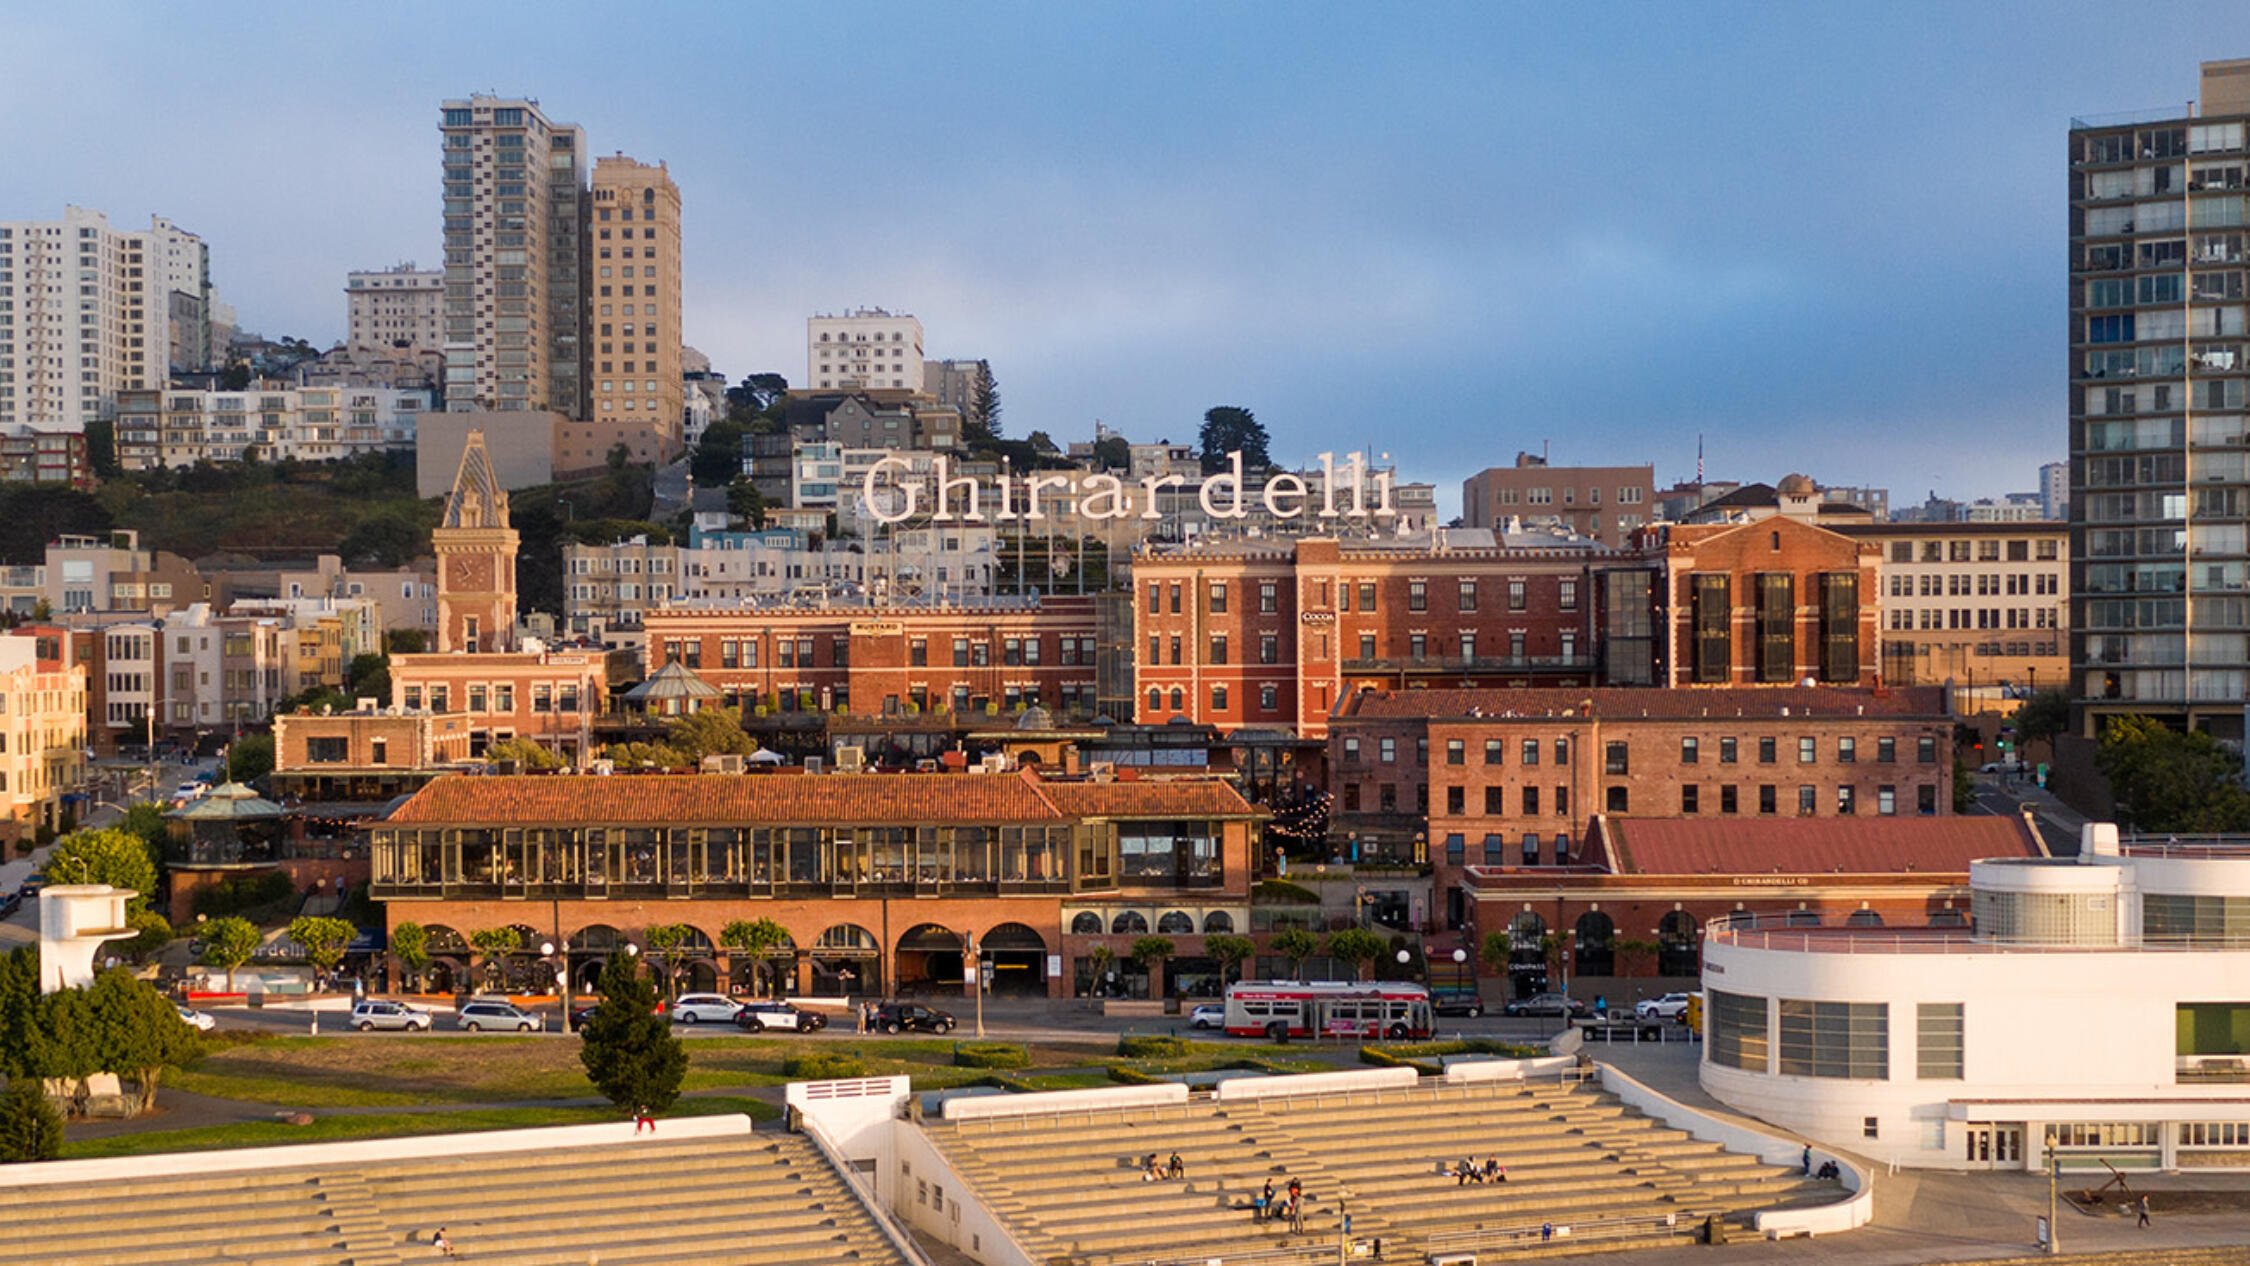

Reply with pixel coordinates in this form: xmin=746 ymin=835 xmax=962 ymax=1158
xmin=587 ymin=155 xmax=686 ymax=438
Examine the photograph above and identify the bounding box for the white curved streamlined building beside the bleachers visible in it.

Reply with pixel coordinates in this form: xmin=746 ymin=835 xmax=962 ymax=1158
xmin=1701 ymin=825 xmax=2250 ymax=1169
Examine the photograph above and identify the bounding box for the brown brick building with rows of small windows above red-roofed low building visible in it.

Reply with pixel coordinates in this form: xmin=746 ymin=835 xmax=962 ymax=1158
xmin=1328 ymin=686 xmax=1953 ymax=924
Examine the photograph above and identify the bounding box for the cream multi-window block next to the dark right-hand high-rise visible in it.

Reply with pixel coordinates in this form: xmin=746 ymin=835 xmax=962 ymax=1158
xmin=1836 ymin=522 xmax=2070 ymax=693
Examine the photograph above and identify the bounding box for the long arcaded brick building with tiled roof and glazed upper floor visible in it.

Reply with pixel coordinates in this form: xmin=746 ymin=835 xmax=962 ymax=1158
xmin=360 ymin=774 xmax=1258 ymax=998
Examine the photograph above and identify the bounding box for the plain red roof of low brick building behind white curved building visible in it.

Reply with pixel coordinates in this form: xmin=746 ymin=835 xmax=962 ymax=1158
xmin=1595 ymin=814 xmax=2045 ymax=875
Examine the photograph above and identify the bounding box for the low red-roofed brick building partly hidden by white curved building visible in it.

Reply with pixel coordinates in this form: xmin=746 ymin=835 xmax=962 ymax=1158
xmin=1463 ymin=814 xmax=2045 ymax=1007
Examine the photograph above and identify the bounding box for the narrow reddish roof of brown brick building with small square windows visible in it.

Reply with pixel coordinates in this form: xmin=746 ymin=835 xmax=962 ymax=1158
xmin=1346 ymin=686 xmax=1944 ymax=720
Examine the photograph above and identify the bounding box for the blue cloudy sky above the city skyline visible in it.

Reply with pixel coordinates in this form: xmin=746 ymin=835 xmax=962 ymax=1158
xmin=0 ymin=0 xmax=2250 ymax=508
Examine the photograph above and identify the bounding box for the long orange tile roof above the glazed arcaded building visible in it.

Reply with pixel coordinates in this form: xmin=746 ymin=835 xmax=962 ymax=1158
xmin=387 ymin=774 xmax=1253 ymax=828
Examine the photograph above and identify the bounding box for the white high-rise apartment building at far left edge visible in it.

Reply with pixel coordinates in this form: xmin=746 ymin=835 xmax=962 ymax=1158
xmin=0 ymin=207 xmax=212 ymax=432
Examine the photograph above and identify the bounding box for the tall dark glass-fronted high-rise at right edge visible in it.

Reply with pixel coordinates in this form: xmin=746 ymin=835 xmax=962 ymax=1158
xmin=2070 ymin=61 xmax=2250 ymax=738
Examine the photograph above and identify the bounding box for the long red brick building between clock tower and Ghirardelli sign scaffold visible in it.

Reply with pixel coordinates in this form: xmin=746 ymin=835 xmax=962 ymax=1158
xmin=646 ymin=596 xmax=1116 ymax=717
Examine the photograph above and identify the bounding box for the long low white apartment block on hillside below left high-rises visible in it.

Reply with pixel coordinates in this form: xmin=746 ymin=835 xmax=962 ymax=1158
xmin=117 ymin=385 xmax=430 ymax=470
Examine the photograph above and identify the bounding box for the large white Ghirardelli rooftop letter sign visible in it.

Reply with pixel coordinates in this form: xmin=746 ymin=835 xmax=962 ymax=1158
xmin=860 ymin=452 xmax=1397 ymax=524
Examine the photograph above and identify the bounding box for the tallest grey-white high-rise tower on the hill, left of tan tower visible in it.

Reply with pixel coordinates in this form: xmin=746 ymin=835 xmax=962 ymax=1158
xmin=439 ymin=97 xmax=587 ymax=418
